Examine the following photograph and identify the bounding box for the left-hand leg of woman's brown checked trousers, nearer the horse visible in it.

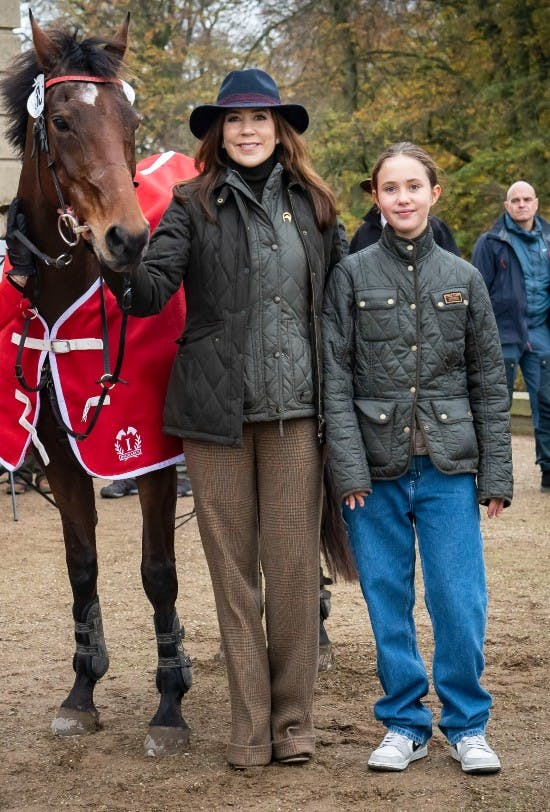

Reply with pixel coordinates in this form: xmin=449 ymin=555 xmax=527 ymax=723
xmin=183 ymin=426 xmax=272 ymax=767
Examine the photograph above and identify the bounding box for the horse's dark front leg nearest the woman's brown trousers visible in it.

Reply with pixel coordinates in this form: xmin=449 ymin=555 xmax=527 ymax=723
xmin=137 ymin=467 xmax=191 ymax=756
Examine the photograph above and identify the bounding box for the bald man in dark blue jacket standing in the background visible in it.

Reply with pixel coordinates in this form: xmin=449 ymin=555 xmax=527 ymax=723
xmin=472 ymin=180 xmax=550 ymax=494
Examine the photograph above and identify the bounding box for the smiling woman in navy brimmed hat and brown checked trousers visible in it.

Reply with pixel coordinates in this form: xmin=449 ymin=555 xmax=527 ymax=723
xmin=106 ymin=69 xmax=343 ymax=768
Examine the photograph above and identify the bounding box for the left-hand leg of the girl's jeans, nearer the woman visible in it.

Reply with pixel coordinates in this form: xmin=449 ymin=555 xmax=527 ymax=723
xmin=344 ymin=468 xmax=432 ymax=743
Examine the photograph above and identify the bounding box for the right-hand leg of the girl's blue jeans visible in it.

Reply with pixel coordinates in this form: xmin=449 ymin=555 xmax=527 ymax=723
xmin=415 ymin=457 xmax=491 ymax=744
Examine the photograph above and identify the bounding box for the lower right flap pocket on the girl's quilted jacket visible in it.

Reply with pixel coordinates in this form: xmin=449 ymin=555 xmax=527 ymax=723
xmin=427 ymin=398 xmax=479 ymax=469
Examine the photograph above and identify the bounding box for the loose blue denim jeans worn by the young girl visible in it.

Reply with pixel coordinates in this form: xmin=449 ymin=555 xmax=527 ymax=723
xmin=344 ymin=456 xmax=491 ymax=744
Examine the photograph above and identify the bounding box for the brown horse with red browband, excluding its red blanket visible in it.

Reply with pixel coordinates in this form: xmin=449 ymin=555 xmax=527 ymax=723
xmin=1 ymin=12 xmax=191 ymax=755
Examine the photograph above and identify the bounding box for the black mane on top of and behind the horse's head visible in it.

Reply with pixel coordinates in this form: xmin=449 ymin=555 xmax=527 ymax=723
xmin=0 ymin=29 xmax=125 ymax=157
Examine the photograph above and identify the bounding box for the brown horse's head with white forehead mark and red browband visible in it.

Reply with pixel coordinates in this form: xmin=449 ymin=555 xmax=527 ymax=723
xmin=3 ymin=13 xmax=149 ymax=271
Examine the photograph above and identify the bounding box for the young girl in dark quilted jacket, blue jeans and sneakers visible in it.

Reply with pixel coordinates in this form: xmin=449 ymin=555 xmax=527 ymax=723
xmin=323 ymin=142 xmax=512 ymax=773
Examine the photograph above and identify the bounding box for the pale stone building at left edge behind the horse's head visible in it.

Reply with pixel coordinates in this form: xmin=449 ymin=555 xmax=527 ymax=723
xmin=0 ymin=0 xmax=21 ymax=235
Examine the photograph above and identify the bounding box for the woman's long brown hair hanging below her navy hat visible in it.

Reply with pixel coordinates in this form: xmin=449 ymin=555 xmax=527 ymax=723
xmin=174 ymin=109 xmax=337 ymax=230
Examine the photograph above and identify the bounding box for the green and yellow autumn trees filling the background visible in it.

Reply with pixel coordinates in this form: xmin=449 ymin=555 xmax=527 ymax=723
xmin=27 ymin=0 xmax=550 ymax=251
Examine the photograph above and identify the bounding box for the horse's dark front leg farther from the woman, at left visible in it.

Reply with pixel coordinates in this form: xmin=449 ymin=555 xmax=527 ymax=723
xmin=39 ymin=406 xmax=109 ymax=736
